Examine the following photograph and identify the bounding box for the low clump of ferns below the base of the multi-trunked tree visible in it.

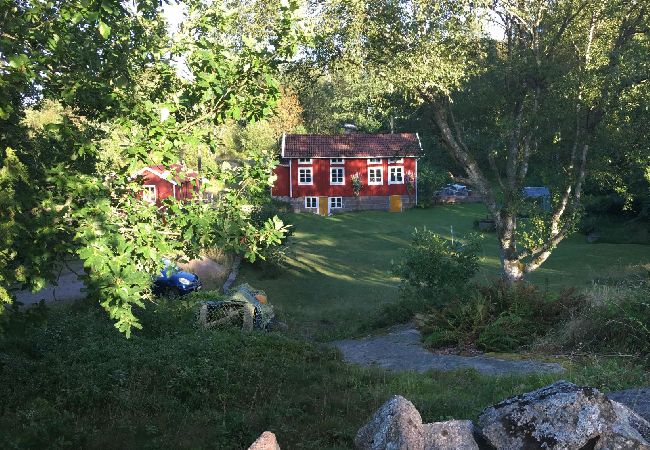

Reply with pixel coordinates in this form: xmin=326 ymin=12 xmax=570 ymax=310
xmin=417 ymin=281 xmax=586 ymax=352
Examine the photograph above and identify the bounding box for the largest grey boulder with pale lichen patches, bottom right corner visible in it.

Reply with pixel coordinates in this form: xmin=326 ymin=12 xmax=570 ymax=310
xmin=478 ymin=381 xmax=650 ymax=450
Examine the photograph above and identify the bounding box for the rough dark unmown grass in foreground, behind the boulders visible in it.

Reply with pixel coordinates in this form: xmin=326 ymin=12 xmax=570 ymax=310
xmin=0 ymin=299 xmax=647 ymax=449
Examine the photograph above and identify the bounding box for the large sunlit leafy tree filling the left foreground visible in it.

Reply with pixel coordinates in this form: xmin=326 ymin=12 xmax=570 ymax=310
xmin=0 ymin=1 xmax=302 ymax=336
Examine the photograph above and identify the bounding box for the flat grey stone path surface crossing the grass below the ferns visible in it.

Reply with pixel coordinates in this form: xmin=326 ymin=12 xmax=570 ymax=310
xmin=332 ymin=326 xmax=564 ymax=375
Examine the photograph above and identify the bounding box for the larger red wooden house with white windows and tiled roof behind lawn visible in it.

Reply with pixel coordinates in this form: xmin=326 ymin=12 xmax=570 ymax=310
xmin=272 ymin=133 xmax=422 ymax=215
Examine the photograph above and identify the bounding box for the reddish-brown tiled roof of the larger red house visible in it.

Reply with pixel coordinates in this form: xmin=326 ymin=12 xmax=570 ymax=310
xmin=282 ymin=133 xmax=422 ymax=158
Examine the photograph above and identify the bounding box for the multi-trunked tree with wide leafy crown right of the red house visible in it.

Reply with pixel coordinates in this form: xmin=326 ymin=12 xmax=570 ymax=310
xmin=310 ymin=0 xmax=650 ymax=280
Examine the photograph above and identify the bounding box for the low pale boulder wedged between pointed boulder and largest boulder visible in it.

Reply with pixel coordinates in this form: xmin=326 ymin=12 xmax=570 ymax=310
xmin=422 ymin=420 xmax=481 ymax=450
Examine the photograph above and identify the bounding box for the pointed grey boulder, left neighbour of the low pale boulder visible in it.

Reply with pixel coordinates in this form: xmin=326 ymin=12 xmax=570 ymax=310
xmin=354 ymin=395 xmax=424 ymax=450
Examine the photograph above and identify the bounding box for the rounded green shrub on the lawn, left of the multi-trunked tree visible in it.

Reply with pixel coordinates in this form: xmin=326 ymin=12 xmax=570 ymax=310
xmin=394 ymin=229 xmax=480 ymax=301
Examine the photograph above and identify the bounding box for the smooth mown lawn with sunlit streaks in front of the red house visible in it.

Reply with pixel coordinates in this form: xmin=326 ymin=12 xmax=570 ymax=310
xmin=242 ymin=204 xmax=650 ymax=341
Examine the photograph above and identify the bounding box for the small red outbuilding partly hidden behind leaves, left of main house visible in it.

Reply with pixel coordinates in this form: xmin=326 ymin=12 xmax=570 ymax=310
xmin=133 ymin=164 xmax=200 ymax=205
